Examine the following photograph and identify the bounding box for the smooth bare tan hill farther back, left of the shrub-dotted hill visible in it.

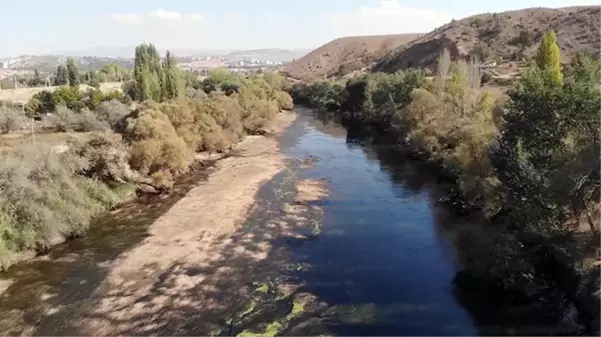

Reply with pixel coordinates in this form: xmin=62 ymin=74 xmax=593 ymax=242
xmin=282 ymin=34 xmax=422 ymax=80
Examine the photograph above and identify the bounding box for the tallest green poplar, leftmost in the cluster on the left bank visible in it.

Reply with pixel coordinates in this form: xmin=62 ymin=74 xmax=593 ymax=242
xmin=134 ymin=43 xmax=162 ymax=101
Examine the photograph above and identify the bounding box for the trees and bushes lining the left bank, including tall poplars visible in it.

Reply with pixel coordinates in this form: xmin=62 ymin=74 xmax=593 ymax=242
xmin=0 ymin=44 xmax=292 ymax=268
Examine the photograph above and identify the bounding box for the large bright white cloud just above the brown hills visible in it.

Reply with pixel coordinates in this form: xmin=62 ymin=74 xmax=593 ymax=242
xmin=327 ymin=0 xmax=453 ymax=35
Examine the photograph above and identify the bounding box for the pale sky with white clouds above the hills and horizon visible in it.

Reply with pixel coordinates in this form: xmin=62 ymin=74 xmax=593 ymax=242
xmin=0 ymin=0 xmax=599 ymax=56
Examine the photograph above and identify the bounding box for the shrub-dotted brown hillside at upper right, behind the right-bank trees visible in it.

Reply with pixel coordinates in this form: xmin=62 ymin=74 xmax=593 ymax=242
xmin=373 ymin=6 xmax=601 ymax=72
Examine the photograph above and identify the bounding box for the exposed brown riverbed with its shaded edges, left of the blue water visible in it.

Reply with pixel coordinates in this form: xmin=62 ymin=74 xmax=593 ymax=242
xmin=0 ymin=113 xmax=326 ymax=337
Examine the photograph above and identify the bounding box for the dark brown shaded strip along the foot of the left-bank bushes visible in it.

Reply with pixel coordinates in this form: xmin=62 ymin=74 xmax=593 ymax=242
xmin=0 ymin=162 xmax=223 ymax=336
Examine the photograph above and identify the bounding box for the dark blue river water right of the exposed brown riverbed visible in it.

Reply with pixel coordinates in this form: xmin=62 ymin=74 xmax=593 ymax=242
xmin=285 ymin=113 xmax=478 ymax=336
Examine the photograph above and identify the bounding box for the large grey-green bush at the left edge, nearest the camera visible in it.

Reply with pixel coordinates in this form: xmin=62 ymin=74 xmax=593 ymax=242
xmin=0 ymin=144 xmax=125 ymax=267
